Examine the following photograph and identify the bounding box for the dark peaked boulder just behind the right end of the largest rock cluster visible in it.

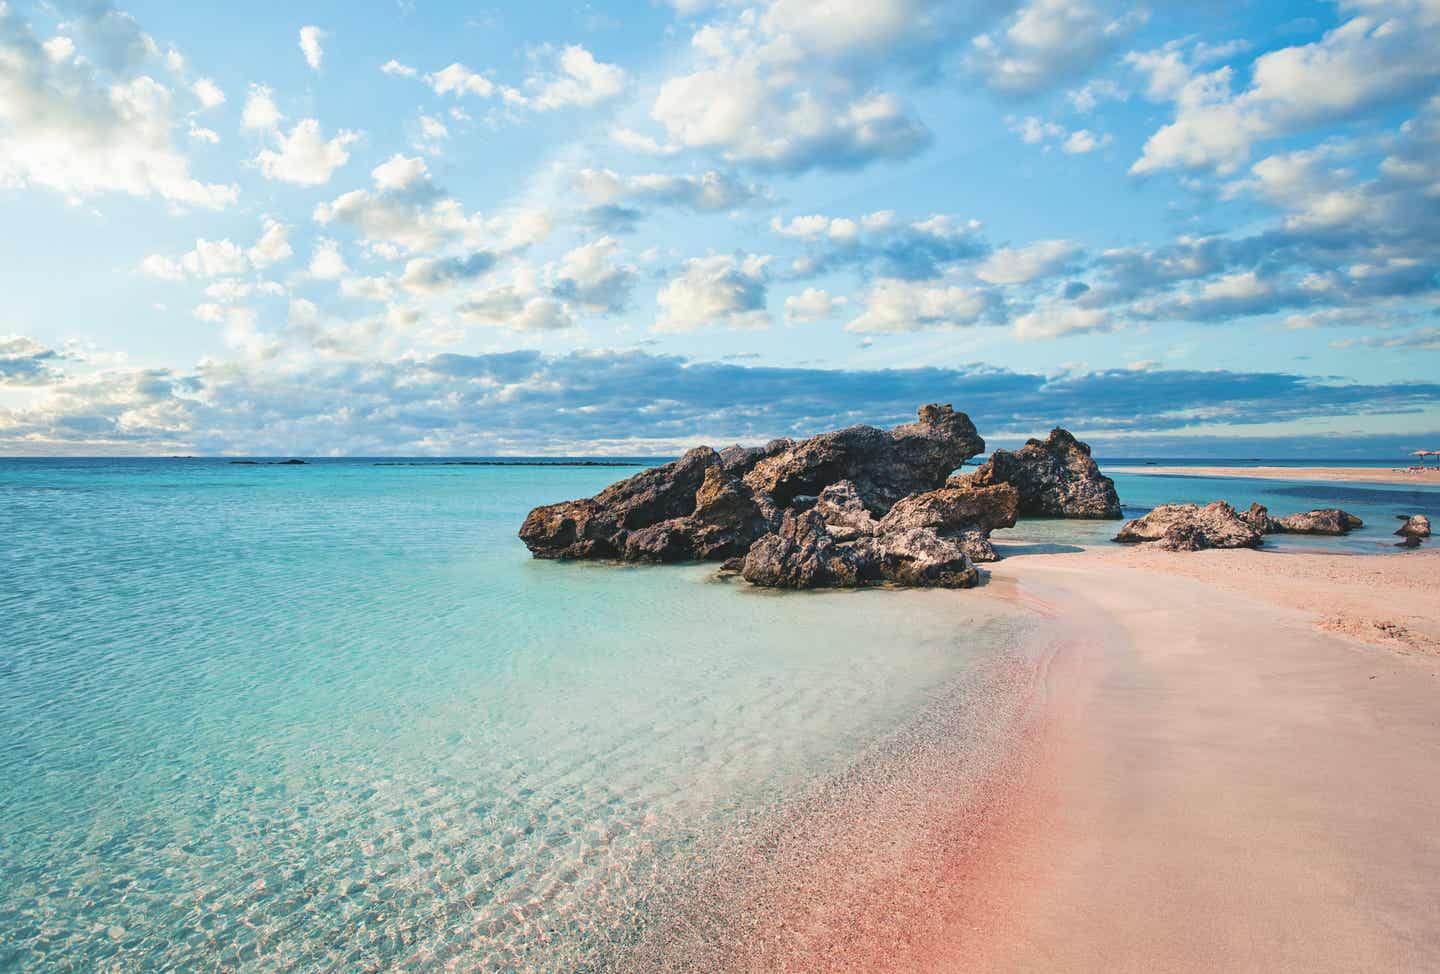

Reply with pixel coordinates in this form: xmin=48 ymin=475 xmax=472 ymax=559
xmin=956 ymin=428 xmax=1122 ymax=519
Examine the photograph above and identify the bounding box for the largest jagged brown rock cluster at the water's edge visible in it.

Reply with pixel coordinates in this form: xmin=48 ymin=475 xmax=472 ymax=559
xmin=520 ymin=405 xmax=1017 ymax=588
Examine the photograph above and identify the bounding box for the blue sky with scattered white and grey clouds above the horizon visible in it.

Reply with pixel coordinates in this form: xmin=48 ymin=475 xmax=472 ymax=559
xmin=0 ymin=0 xmax=1440 ymax=457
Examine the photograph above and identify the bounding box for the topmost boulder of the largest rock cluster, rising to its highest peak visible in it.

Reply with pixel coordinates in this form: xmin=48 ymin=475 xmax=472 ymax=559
xmin=744 ymin=405 xmax=985 ymax=516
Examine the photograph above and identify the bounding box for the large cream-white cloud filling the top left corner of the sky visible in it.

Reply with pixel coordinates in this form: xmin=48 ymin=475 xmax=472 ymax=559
xmin=0 ymin=4 xmax=238 ymax=209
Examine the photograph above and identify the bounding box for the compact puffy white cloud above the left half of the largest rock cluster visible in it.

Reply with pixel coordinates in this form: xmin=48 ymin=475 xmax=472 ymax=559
xmin=654 ymin=255 xmax=770 ymax=331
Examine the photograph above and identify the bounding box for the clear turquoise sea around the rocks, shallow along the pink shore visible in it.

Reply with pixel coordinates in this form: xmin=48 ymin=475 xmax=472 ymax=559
xmin=0 ymin=458 xmax=1440 ymax=973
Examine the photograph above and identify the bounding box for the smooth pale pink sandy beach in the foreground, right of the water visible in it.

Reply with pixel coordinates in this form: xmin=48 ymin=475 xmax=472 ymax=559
xmin=961 ymin=549 xmax=1440 ymax=973
